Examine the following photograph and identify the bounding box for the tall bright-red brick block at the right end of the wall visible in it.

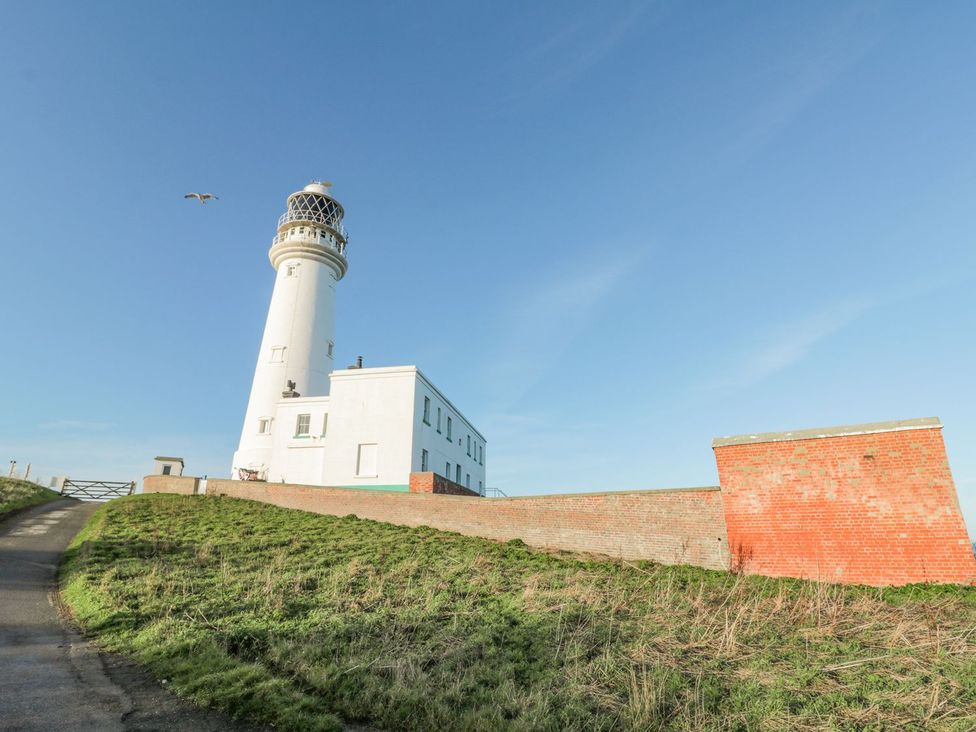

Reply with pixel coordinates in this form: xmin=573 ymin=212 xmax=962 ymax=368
xmin=715 ymin=420 xmax=976 ymax=586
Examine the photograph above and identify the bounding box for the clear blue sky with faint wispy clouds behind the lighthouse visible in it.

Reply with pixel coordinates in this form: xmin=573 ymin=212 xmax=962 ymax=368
xmin=0 ymin=1 xmax=976 ymax=533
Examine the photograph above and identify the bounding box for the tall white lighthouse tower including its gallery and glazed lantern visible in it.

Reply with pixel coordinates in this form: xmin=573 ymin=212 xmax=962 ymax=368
xmin=233 ymin=182 xmax=348 ymax=478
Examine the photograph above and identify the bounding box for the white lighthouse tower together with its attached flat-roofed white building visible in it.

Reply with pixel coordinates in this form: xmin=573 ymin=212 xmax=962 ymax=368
xmin=233 ymin=183 xmax=485 ymax=493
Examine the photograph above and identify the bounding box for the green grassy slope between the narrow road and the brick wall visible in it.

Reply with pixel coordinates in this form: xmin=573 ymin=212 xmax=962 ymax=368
xmin=62 ymin=495 xmax=976 ymax=730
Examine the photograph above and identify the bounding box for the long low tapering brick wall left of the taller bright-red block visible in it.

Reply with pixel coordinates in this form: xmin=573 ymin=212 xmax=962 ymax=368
xmin=207 ymin=478 xmax=728 ymax=569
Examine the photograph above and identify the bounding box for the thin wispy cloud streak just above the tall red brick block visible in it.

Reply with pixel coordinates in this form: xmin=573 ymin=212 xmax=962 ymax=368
xmin=706 ymin=299 xmax=876 ymax=391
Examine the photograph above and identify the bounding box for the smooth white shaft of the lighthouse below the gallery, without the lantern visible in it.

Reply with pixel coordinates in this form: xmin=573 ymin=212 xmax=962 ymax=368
xmin=233 ymin=256 xmax=338 ymax=472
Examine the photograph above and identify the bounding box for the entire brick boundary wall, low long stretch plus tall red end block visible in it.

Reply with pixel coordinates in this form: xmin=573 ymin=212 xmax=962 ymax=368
xmin=144 ymin=418 xmax=976 ymax=586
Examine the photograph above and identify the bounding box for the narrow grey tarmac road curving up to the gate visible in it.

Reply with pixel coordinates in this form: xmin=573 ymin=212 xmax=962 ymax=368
xmin=0 ymin=500 xmax=263 ymax=732
